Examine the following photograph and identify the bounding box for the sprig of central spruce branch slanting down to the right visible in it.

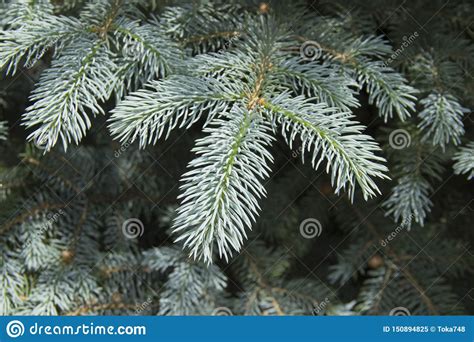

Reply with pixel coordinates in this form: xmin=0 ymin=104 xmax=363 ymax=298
xmin=264 ymin=94 xmax=387 ymax=199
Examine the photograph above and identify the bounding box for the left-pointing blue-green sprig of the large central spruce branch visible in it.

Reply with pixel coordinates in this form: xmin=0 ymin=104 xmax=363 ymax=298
xmin=109 ymin=76 xmax=243 ymax=147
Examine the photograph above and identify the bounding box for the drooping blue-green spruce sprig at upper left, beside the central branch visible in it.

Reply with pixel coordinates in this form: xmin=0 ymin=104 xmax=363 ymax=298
xmin=23 ymin=39 xmax=116 ymax=151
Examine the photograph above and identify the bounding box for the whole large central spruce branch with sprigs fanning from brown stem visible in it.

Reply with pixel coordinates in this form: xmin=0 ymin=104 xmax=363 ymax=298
xmin=110 ymin=17 xmax=387 ymax=262
